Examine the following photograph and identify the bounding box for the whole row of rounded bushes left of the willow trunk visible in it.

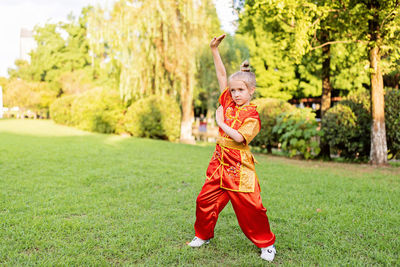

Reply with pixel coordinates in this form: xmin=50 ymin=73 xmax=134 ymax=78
xmin=50 ymin=88 xmax=180 ymax=141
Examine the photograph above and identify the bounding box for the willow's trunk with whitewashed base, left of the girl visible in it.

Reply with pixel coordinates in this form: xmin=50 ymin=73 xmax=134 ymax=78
xmin=180 ymin=74 xmax=195 ymax=144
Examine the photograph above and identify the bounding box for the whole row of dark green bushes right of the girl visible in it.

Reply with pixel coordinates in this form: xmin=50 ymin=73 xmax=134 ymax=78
xmin=252 ymin=89 xmax=400 ymax=161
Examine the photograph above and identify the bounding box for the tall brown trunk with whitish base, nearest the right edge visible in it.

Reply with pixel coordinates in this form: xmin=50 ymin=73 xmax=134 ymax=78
xmin=368 ymin=4 xmax=387 ymax=165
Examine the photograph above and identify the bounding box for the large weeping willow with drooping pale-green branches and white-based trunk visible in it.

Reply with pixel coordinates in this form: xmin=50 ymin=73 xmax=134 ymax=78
xmin=89 ymin=0 xmax=219 ymax=141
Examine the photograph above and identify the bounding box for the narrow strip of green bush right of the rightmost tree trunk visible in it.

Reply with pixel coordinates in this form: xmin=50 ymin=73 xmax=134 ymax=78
xmin=385 ymin=89 xmax=400 ymax=159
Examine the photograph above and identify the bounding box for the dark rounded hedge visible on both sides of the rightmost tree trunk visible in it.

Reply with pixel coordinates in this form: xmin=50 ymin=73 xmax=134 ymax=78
xmin=322 ymin=89 xmax=400 ymax=161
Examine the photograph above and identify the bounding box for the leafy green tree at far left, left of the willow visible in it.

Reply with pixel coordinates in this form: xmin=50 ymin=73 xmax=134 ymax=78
xmin=9 ymin=7 xmax=93 ymax=95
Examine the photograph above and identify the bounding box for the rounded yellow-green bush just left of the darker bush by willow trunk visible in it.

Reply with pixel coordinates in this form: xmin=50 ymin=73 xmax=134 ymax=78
xmin=71 ymin=88 xmax=123 ymax=133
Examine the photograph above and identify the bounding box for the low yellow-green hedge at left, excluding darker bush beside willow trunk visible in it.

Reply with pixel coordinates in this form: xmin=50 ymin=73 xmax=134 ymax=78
xmin=50 ymin=88 xmax=123 ymax=133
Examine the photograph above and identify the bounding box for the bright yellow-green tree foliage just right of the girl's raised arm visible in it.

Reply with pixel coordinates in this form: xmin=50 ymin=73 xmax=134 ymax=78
xmin=236 ymin=0 xmax=298 ymax=100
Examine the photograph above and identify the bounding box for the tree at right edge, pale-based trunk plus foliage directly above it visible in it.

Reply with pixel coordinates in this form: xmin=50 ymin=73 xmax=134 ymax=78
xmin=355 ymin=0 xmax=400 ymax=165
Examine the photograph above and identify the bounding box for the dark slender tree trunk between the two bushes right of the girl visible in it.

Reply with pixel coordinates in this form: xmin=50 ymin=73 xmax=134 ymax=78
xmin=319 ymin=30 xmax=332 ymax=159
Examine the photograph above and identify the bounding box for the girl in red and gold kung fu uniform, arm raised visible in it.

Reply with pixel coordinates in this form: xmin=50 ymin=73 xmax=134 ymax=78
xmin=188 ymin=34 xmax=276 ymax=261
